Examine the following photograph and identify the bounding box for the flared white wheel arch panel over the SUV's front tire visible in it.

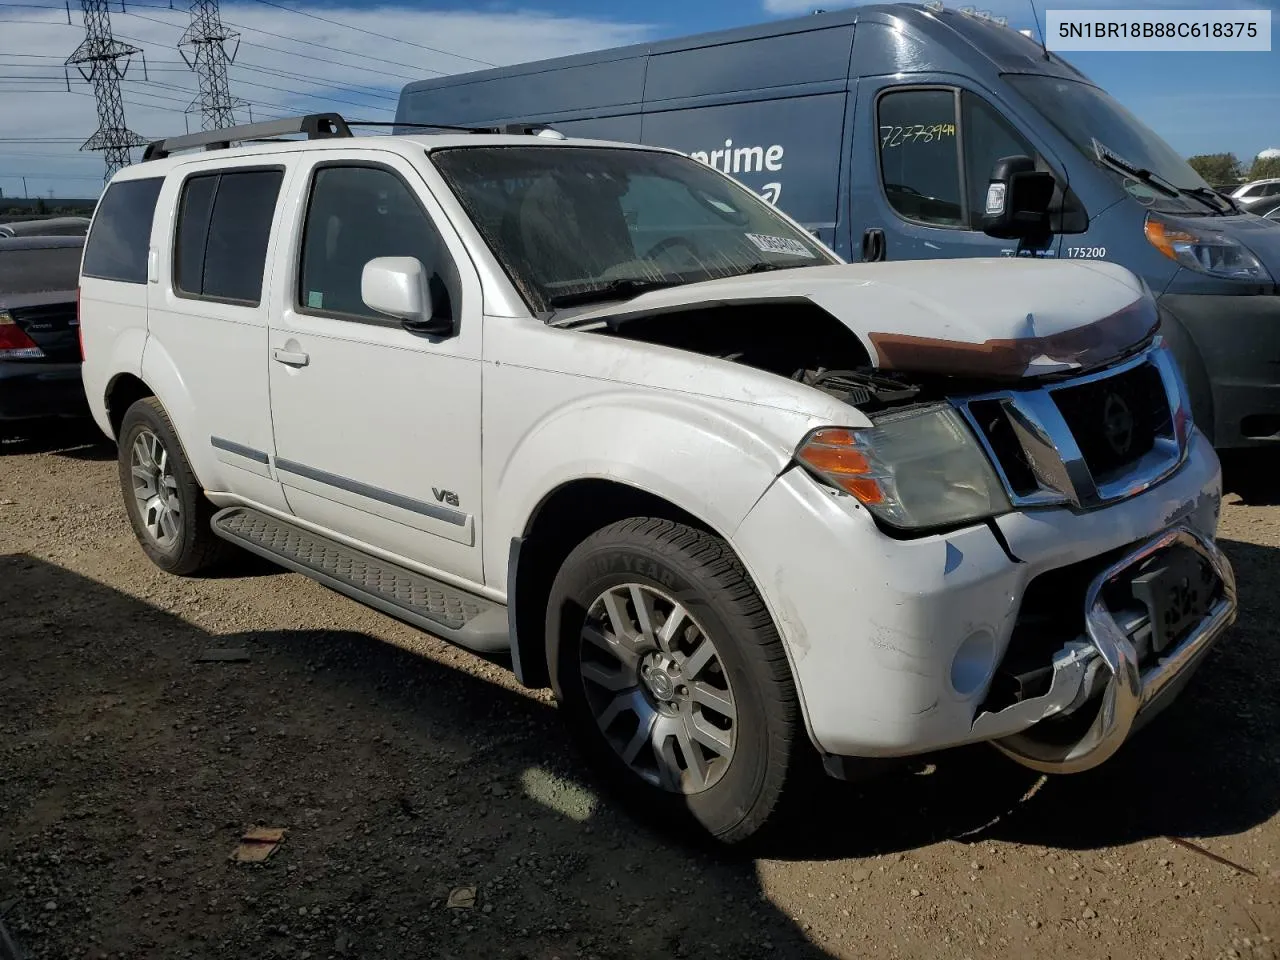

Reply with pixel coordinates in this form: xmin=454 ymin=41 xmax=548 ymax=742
xmin=485 ymin=389 xmax=826 ymax=584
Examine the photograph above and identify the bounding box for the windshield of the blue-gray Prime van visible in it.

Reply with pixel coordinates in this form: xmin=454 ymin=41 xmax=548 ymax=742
xmin=1005 ymin=74 xmax=1208 ymax=212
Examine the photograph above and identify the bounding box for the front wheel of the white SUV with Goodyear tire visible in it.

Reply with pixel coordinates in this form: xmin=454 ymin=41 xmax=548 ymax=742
xmin=547 ymin=518 xmax=800 ymax=844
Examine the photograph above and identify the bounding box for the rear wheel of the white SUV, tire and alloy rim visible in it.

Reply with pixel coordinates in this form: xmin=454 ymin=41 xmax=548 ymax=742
xmin=118 ymin=397 xmax=233 ymax=576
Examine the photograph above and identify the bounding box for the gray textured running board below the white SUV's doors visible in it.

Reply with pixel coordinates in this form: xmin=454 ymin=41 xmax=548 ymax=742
xmin=212 ymin=507 xmax=511 ymax=653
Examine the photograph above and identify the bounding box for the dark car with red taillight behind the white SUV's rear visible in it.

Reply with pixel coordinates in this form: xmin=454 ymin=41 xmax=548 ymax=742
xmin=0 ymin=237 xmax=88 ymax=436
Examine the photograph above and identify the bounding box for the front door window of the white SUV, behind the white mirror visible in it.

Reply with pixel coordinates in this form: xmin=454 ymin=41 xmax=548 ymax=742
xmin=297 ymin=165 xmax=457 ymax=323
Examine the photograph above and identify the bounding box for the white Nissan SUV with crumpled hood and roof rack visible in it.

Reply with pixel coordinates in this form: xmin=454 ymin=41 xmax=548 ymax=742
xmin=81 ymin=116 xmax=1235 ymax=841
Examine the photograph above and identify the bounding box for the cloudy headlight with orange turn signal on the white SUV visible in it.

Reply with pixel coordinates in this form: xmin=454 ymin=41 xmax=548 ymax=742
xmin=796 ymin=404 xmax=1010 ymax=530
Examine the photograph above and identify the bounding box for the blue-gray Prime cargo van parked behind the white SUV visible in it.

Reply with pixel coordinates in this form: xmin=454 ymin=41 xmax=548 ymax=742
xmin=397 ymin=4 xmax=1280 ymax=448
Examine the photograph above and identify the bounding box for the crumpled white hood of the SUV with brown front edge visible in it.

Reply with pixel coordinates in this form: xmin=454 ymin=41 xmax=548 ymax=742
xmin=573 ymin=257 xmax=1157 ymax=378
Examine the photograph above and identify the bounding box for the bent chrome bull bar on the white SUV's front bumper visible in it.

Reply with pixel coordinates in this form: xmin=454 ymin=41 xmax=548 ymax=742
xmin=973 ymin=527 xmax=1236 ymax=773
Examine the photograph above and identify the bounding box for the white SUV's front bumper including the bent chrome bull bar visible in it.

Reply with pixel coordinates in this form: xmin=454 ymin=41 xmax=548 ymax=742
xmin=732 ymin=431 xmax=1234 ymax=769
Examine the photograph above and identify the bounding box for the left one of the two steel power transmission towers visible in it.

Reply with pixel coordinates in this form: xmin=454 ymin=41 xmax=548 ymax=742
xmin=67 ymin=0 xmax=147 ymax=179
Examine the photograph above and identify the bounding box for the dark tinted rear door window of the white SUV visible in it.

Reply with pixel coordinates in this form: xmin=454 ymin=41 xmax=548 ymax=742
xmin=173 ymin=170 xmax=284 ymax=307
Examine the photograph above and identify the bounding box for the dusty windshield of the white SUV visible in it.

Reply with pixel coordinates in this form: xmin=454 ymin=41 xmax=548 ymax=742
xmin=431 ymin=146 xmax=838 ymax=314
